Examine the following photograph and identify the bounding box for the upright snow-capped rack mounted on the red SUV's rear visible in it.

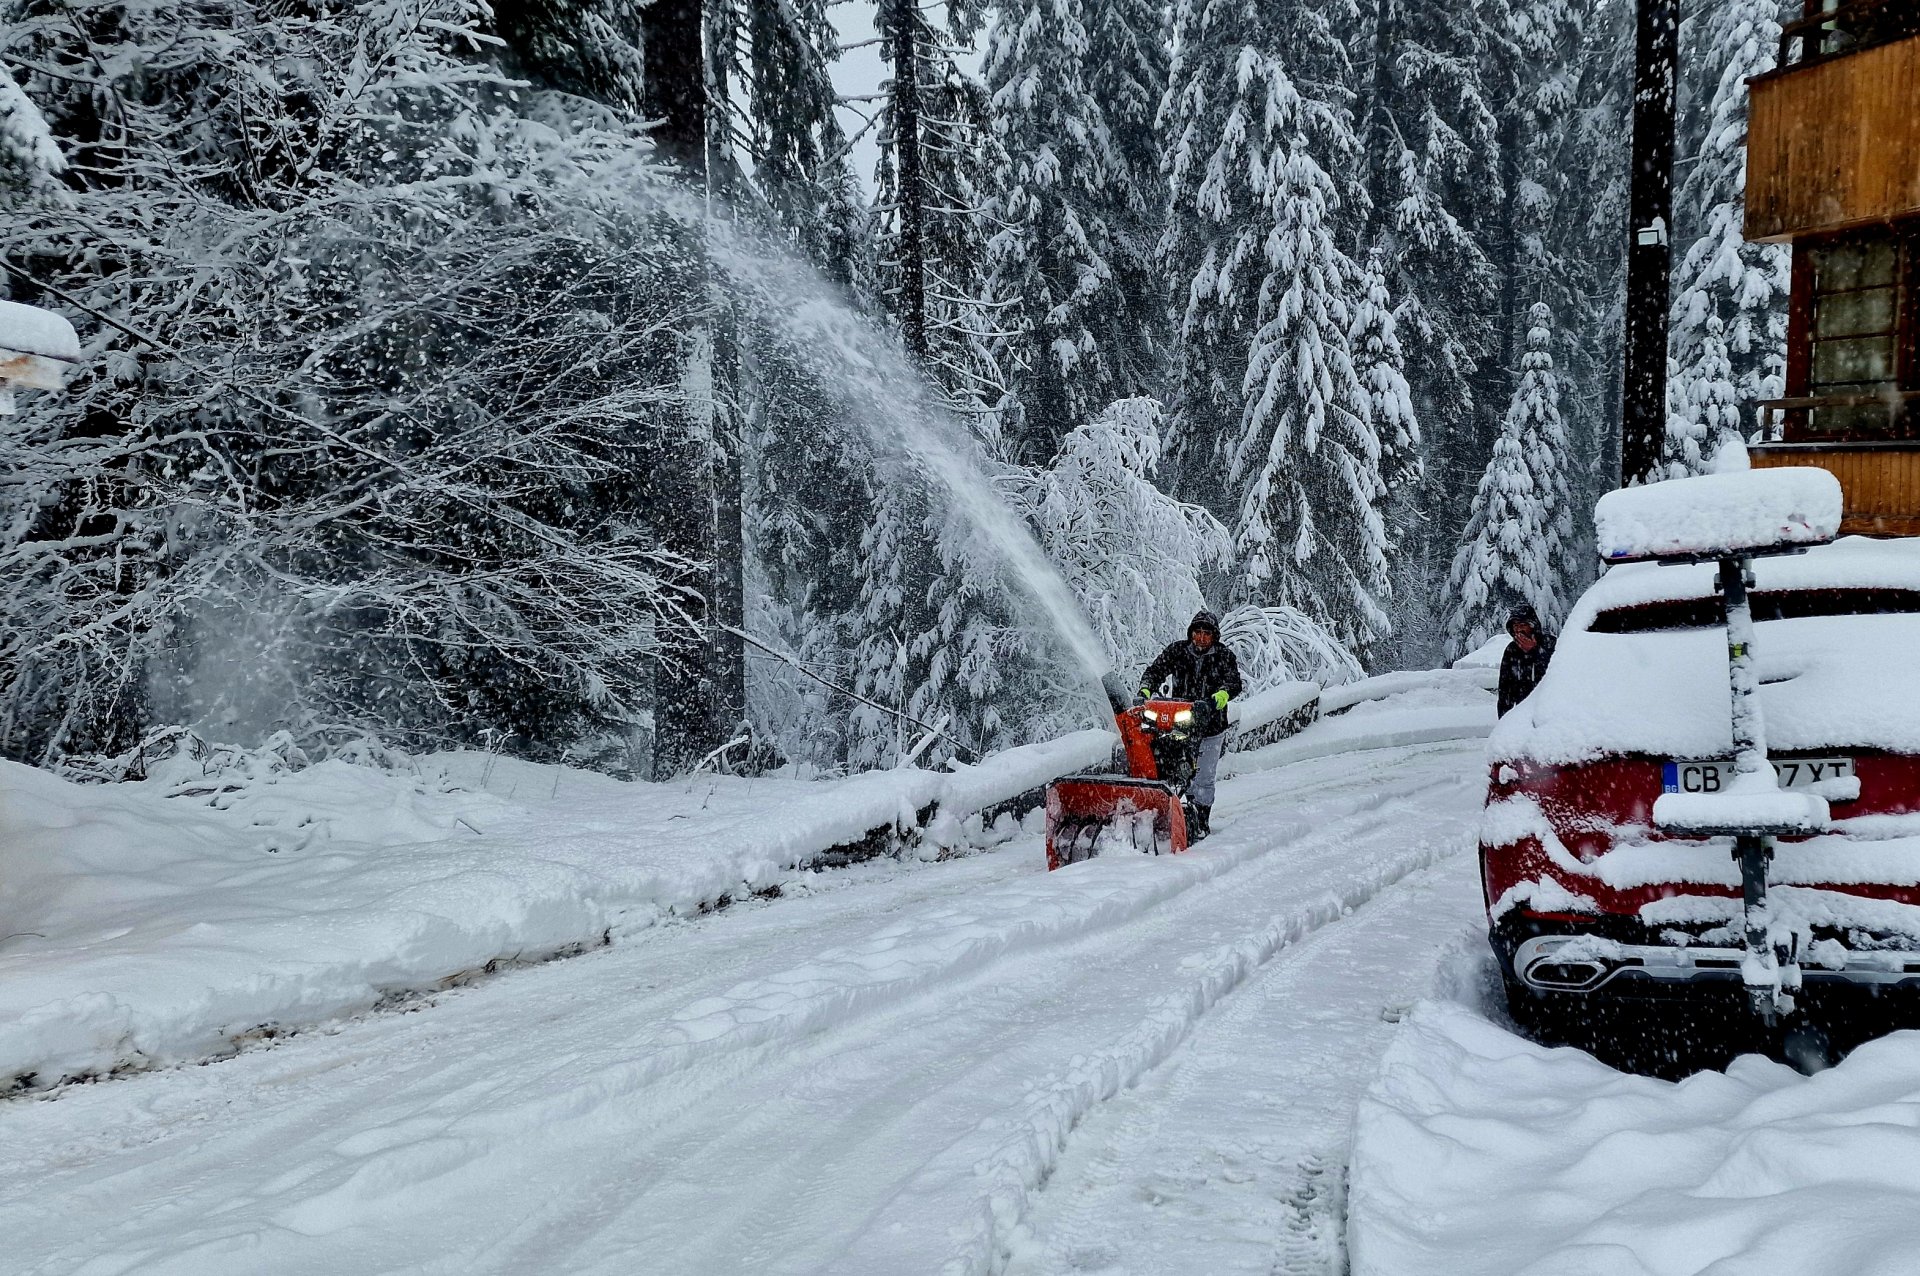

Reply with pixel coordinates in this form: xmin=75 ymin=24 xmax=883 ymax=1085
xmin=1594 ymin=466 xmax=1841 ymax=1027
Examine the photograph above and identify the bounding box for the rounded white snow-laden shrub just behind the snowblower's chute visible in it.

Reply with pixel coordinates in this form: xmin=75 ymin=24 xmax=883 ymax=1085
xmin=1004 ymin=399 xmax=1233 ymax=670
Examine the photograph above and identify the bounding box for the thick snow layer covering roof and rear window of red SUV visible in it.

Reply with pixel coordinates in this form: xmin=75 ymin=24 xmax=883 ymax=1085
xmin=1488 ymin=537 xmax=1920 ymax=764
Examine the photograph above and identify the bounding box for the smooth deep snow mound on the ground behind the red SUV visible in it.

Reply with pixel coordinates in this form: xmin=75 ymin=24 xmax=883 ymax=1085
xmin=1348 ymin=1002 xmax=1920 ymax=1276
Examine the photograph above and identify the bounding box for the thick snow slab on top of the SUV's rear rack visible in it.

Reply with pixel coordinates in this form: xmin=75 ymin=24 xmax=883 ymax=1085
xmin=1594 ymin=466 xmax=1841 ymax=562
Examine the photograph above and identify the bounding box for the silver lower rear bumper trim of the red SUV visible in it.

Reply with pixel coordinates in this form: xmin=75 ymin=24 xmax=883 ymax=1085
xmin=1494 ymin=934 xmax=1920 ymax=992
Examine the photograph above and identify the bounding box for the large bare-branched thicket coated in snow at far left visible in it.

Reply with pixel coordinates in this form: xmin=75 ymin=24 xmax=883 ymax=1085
xmin=0 ymin=0 xmax=695 ymax=760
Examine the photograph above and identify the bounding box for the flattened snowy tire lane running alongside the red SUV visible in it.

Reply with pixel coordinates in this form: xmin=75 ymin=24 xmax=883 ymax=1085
xmin=1006 ymin=851 xmax=1478 ymax=1276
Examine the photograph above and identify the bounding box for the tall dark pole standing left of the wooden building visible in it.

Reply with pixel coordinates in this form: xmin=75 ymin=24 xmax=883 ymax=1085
xmin=1620 ymin=0 xmax=1680 ymax=487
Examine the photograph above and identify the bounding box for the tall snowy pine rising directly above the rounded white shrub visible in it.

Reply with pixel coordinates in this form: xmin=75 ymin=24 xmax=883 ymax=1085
xmin=983 ymin=0 xmax=1142 ymax=464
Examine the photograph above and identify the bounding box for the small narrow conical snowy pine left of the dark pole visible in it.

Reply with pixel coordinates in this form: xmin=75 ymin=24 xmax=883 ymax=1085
xmin=1446 ymin=303 xmax=1572 ymax=654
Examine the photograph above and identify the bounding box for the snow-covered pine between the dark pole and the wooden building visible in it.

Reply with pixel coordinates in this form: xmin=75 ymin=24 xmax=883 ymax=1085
xmin=1667 ymin=0 xmax=1789 ymax=474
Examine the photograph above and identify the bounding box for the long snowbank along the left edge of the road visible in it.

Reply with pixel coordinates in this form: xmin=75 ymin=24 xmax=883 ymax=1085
xmin=0 ymin=748 xmax=1067 ymax=1088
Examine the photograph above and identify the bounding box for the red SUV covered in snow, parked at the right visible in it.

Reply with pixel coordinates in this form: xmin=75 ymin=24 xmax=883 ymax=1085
xmin=1480 ymin=537 xmax=1920 ymax=1053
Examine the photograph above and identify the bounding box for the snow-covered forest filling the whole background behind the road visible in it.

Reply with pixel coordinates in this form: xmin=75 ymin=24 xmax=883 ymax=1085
xmin=0 ymin=0 xmax=1786 ymax=777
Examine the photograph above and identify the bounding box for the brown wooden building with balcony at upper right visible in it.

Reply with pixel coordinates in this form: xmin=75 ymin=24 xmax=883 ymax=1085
xmin=1745 ymin=0 xmax=1920 ymax=535
